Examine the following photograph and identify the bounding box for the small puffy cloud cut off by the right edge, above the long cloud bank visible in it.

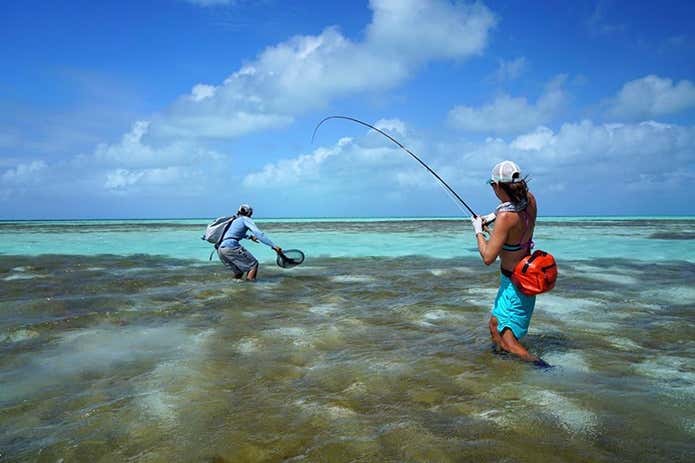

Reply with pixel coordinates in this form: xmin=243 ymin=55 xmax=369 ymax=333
xmin=608 ymin=75 xmax=695 ymax=120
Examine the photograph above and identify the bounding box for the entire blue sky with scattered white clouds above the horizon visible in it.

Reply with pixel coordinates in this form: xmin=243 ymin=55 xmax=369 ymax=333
xmin=0 ymin=0 xmax=695 ymax=220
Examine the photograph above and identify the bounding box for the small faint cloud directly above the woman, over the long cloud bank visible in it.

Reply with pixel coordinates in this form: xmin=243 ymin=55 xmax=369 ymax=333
xmin=448 ymin=76 xmax=567 ymax=134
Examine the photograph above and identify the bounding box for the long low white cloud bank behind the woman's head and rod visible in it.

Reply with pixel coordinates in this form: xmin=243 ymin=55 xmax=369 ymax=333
xmin=244 ymin=120 xmax=695 ymax=210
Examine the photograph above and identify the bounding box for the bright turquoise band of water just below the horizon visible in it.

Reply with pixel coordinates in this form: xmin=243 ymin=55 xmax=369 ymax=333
xmin=0 ymin=217 xmax=695 ymax=262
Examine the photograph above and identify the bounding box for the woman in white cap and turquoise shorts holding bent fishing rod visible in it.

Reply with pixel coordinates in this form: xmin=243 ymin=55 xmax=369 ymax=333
xmin=471 ymin=161 xmax=547 ymax=366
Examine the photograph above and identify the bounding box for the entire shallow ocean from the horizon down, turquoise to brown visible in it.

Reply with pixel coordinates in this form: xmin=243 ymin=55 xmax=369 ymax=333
xmin=0 ymin=217 xmax=695 ymax=463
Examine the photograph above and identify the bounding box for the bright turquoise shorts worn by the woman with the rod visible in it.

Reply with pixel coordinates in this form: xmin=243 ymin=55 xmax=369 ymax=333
xmin=492 ymin=275 xmax=536 ymax=340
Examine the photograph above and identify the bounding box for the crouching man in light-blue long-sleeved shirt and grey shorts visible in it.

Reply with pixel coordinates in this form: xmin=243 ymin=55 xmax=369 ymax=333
xmin=217 ymin=204 xmax=282 ymax=281
